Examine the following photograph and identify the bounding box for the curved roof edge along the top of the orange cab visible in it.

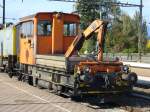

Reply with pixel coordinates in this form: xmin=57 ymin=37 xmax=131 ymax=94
xmin=20 ymin=12 xmax=79 ymax=22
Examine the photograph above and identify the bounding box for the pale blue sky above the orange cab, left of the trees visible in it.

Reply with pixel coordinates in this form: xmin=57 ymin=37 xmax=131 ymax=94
xmin=0 ymin=0 xmax=73 ymax=22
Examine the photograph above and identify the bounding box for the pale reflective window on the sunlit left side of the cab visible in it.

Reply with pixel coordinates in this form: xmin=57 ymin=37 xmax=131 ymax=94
xmin=21 ymin=21 xmax=33 ymax=37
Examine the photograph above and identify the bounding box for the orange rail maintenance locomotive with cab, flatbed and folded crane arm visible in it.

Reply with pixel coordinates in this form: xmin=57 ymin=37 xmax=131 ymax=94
xmin=1 ymin=12 xmax=137 ymax=99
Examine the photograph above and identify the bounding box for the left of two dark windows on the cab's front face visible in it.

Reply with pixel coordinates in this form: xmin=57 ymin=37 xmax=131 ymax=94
xmin=38 ymin=20 xmax=52 ymax=36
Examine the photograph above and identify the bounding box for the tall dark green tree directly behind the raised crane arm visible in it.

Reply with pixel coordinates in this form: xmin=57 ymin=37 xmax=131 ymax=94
xmin=76 ymin=0 xmax=120 ymax=52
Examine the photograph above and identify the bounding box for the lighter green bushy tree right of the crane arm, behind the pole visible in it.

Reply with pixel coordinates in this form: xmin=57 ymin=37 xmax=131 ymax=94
xmin=109 ymin=12 xmax=147 ymax=53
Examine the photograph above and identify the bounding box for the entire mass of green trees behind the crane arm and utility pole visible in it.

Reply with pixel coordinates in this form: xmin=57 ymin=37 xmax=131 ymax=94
xmin=76 ymin=0 xmax=147 ymax=53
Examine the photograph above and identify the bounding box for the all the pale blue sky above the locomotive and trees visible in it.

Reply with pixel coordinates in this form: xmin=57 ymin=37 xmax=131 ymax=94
xmin=0 ymin=0 xmax=150 ymax=35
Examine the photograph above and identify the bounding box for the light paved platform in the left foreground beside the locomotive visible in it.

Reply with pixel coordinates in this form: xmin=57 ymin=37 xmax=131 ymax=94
xmin=0 ymin=73 xmax=125 ymax=112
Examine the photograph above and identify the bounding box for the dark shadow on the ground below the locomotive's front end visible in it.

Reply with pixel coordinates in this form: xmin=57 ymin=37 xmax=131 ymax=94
xmin=73 ymin=95 xmax=150 ymax=112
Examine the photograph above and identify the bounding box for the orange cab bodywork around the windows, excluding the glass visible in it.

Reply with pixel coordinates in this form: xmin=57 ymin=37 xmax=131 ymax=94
xmin=19 ymin=12 xmax=80 ymax=65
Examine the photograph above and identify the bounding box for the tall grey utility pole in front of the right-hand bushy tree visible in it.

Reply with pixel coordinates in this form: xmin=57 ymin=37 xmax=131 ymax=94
xmin=138 ymin=0 xmax=143 ymax=62
